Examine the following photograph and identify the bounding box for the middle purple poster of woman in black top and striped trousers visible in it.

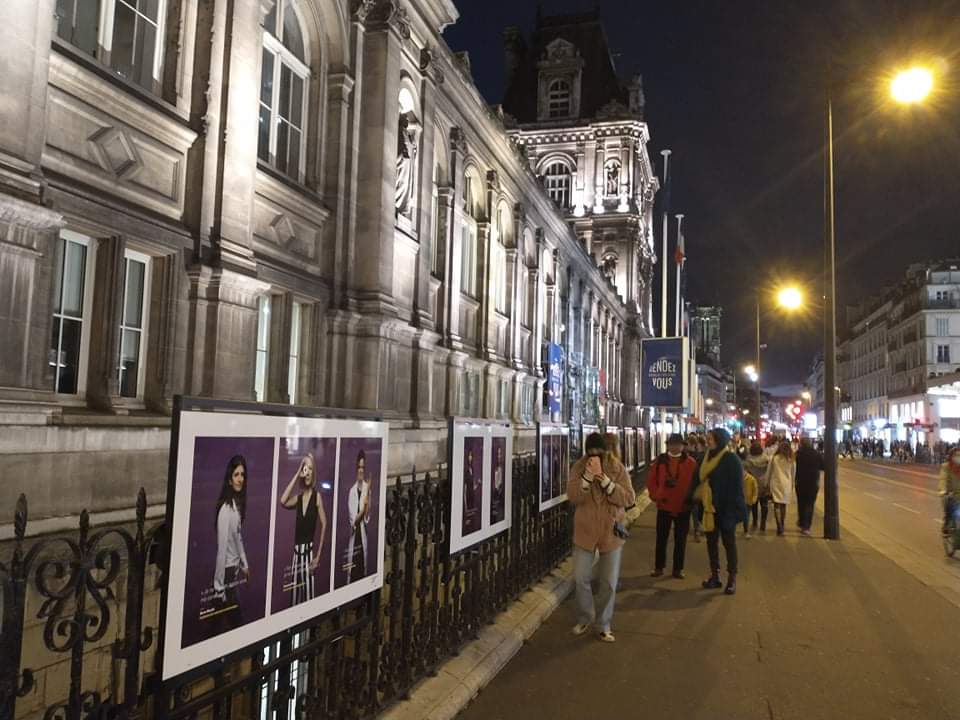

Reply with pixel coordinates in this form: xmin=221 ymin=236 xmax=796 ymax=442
xmin=270 ymin=437 xmax=337 ymax=613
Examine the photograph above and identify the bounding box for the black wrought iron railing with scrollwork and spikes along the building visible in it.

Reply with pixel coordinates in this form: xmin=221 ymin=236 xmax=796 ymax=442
xmin=0 ymin=455 xmax=572 ymax=720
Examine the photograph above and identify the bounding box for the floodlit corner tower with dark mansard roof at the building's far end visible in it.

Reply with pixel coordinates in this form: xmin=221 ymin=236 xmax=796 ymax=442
xmin=503 ymin=10 xmax=659 ymax=434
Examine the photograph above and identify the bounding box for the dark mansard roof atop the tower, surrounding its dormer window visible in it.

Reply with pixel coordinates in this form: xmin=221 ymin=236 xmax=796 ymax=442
xmin=503 ymin=10 xmax=629 ymax=124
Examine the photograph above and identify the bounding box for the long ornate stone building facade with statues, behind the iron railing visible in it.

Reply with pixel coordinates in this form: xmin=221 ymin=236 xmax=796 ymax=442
xmin=0 ymin=0 xmax=655 ymax=517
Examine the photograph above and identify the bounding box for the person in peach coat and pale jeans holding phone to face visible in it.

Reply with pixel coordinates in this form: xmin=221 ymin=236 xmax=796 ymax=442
xmin=567 ymin=433 xmax=636 ymax=642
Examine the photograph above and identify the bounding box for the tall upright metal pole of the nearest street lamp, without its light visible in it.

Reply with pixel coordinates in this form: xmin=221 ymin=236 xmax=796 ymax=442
xmin=823 ymin=91 xmax=840 ymax=540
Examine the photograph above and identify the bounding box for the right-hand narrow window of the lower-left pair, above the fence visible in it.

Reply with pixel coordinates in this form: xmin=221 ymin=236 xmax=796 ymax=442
xmin=117 ymin=250 xmax=150 ymax=398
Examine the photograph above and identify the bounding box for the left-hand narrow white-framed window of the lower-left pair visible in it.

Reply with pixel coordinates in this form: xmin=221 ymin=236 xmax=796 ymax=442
xmin=49 ymin=230 xmax=93 ymax=395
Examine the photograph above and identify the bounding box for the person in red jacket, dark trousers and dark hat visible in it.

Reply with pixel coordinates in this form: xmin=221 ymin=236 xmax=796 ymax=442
xmin=647 ymin=433 xmax=697 ymax=579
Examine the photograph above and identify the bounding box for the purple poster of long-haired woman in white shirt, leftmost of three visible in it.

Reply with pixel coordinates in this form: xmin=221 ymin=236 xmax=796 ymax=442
xmin=181 ymin=437 xmax=274 ymax=647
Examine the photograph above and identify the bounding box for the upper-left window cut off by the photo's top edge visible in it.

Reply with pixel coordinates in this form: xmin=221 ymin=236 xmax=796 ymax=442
xmin=56 ymin=0 xmax=166 ymax=93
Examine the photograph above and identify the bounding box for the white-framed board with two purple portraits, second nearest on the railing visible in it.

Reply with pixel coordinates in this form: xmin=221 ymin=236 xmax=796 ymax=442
xmin=449 ymin=418 xmax=513 ymax=554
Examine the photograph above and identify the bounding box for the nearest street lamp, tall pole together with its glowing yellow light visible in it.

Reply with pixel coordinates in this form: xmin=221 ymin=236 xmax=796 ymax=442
xmin=823 ymin=67 xmax=934 ymax=540
